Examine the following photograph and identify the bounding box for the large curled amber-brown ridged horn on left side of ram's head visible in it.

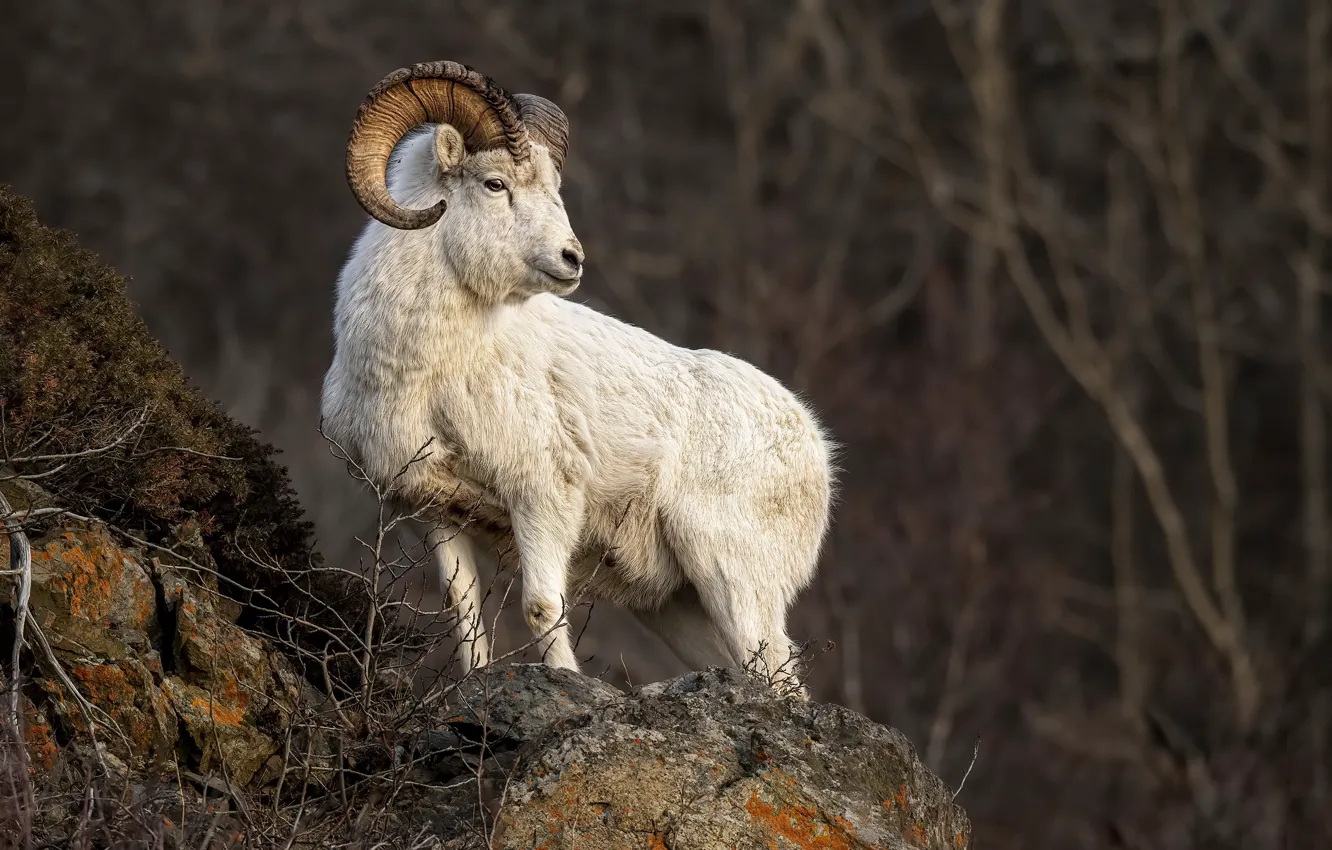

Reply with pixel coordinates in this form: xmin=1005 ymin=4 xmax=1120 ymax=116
xmin=346 ymin=61 xmax=530 ymax=230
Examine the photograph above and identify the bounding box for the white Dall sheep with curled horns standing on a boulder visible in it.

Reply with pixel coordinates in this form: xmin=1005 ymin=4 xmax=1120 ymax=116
xmin=322 ymin=61 xmax=834 ymax=693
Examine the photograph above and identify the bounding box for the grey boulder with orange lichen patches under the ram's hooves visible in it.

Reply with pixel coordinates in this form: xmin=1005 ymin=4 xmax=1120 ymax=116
xmin=452 ymin=665 xmax=971 ymax=850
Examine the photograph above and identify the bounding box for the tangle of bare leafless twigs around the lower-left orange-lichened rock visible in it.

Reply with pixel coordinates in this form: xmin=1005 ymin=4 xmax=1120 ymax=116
xmin=0 ymin=424 xmax=623 ymax=849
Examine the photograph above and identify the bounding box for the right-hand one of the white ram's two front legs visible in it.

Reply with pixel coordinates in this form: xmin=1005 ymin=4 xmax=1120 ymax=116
xmin=513 ymin=500 xmax=583 ymax=670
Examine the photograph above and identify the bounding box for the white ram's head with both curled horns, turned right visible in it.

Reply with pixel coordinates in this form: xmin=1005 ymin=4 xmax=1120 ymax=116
xmin=346 ymin=61 xmax=583 ymax=298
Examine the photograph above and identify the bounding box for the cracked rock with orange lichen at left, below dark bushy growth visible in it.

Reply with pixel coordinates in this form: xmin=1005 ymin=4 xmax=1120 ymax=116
xmin=7 ymin=482 xmax=306 ymax=787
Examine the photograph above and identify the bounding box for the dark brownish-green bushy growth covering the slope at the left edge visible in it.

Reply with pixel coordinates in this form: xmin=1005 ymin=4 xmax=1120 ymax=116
xmin=0 ymin=184 xmax=316 ymax=602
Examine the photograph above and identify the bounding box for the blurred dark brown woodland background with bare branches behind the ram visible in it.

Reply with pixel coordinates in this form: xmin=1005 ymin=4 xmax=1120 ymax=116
xmin=0 ymin=0 xmax=1332 ymax=849
